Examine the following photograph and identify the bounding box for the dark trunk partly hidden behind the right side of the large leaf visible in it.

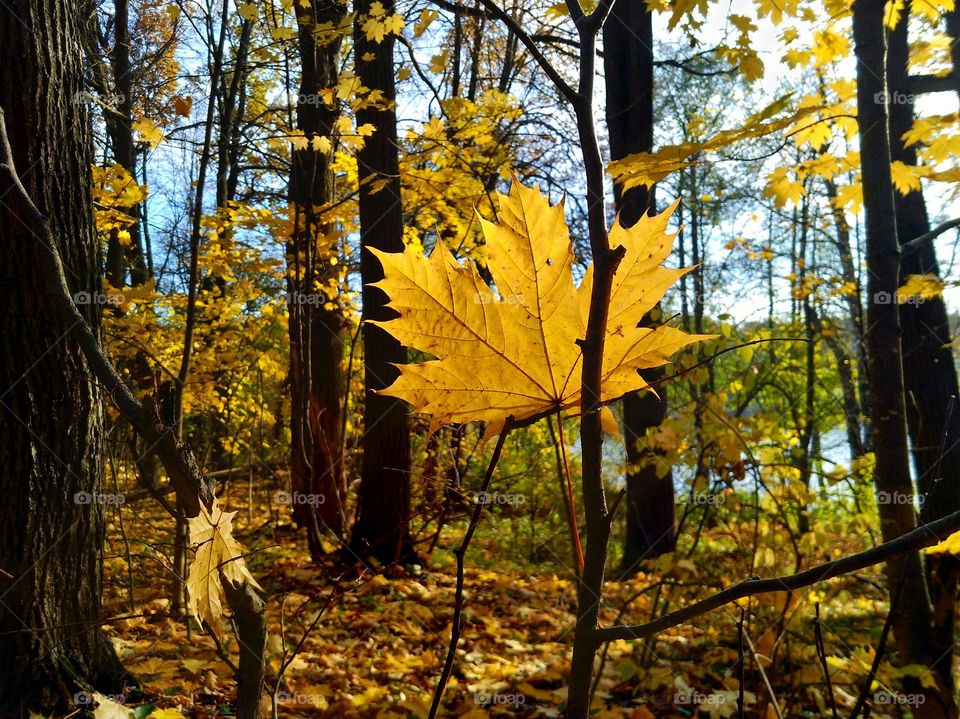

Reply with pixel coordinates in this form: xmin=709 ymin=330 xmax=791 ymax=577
xmin=603 ymin=2 xmax=677 ymax=574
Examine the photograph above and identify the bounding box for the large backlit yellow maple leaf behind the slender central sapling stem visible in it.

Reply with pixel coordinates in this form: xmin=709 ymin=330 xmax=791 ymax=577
xmin=372 ymin=181 xmax=708 ymax=437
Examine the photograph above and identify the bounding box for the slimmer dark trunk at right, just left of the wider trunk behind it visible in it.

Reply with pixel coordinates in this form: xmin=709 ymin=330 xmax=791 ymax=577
xmin=853 ymin=0 xmax=955 ymax=717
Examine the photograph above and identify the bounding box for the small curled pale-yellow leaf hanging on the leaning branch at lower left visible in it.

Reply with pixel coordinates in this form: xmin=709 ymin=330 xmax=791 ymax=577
xmin=187 ymin=500 xmax=260 ymax=631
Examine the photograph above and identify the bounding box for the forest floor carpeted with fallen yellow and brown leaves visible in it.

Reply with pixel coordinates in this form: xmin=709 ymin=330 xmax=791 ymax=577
xmin=104 ymin=476 xmax=904 ymax=719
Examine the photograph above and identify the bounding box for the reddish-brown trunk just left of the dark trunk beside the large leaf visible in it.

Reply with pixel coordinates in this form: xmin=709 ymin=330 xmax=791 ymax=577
xmin=287 ymin=2 xmax=346 ymax=558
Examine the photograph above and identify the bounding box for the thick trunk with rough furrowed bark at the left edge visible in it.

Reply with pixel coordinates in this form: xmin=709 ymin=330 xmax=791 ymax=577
xmin=0 ymin=0 xmax=123 ymax=716
